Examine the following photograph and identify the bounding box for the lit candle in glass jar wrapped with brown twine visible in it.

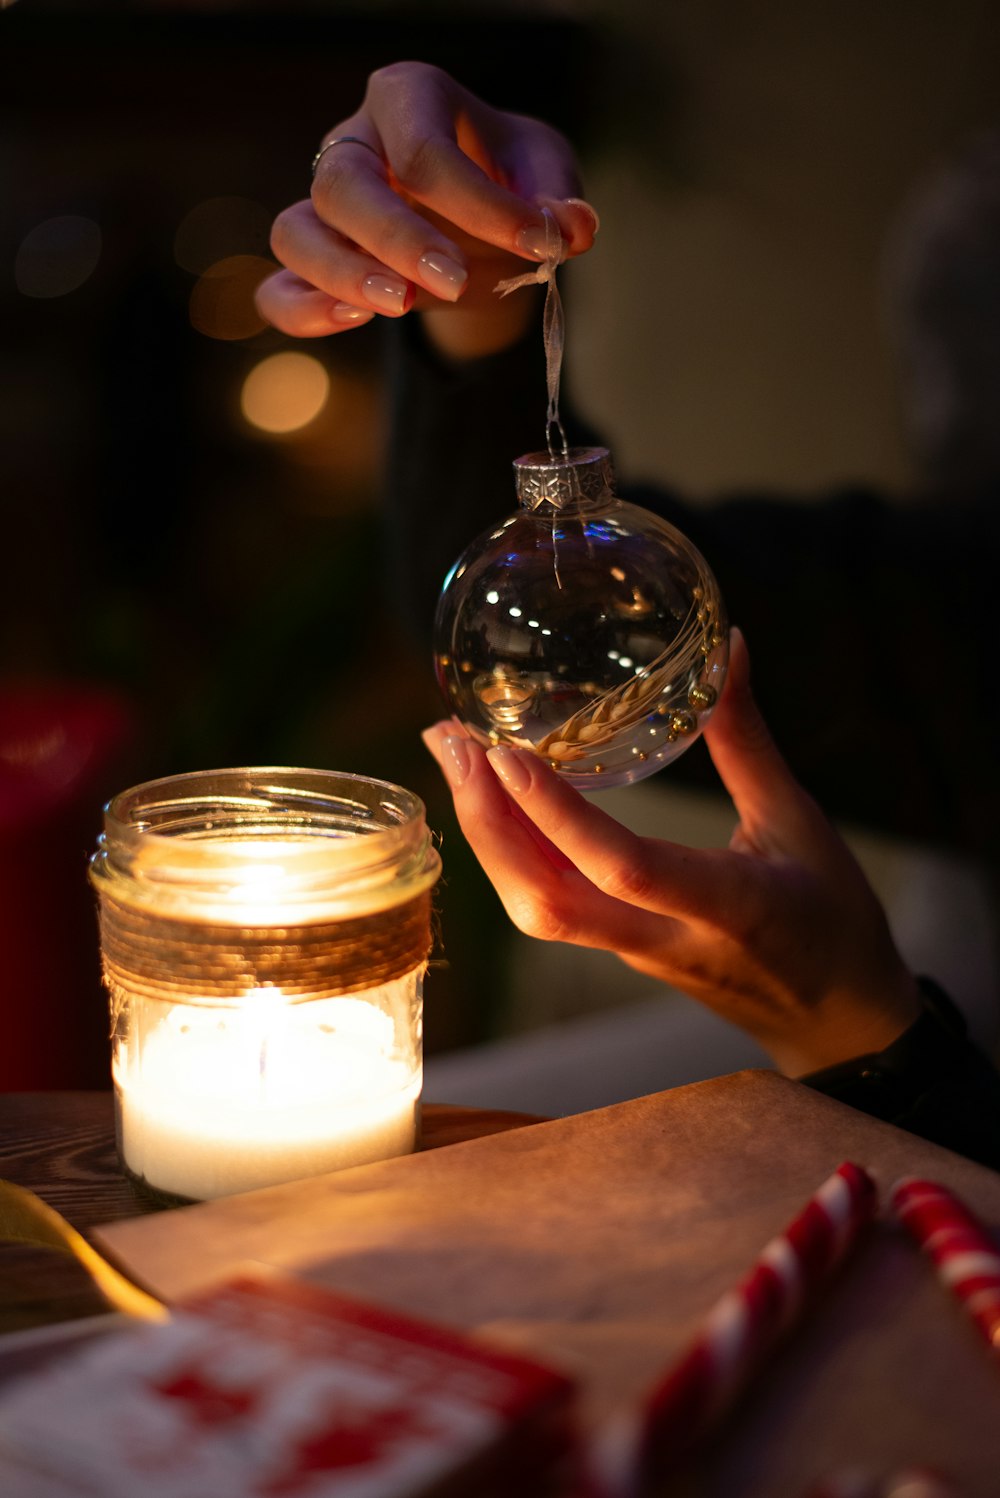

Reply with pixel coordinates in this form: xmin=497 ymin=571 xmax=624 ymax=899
xmin=90 ymin=768 xmax=440 ymax=1201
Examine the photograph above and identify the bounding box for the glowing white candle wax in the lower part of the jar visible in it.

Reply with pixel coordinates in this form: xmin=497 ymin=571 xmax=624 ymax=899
xmin=114 ymin=990 xmax=421 ymax=1201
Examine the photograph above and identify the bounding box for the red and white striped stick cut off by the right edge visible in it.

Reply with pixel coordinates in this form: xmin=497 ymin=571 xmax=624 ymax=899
xmin=889 ymin=1176 xmax=1000 ymax=1353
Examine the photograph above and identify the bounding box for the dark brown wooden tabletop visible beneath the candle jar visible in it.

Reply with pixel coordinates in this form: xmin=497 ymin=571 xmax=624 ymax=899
xmin=0 ymin=1092 xmax=536 ymax=1336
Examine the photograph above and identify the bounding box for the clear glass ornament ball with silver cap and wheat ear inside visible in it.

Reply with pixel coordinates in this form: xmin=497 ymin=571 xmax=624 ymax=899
xmin=434 ymin=448 xmax=729 ymax=791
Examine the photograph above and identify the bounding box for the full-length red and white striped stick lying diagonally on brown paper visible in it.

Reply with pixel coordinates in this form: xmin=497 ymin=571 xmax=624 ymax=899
xmin=636 ymin=1161 xmax=877 ymax=1485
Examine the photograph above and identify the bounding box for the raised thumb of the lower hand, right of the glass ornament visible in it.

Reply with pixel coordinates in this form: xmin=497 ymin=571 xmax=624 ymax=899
xmin=705 ymin=626 xmax=811 ymax=834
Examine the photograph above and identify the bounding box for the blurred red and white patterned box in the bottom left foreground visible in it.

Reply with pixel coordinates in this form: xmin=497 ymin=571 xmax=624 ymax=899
xmin=0 ymin=1275 xmax=576 ymax=1498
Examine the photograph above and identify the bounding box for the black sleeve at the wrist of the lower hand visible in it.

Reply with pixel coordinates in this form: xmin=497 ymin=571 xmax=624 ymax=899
xmin=801 ymin=978 xmax=1000 ymax=1170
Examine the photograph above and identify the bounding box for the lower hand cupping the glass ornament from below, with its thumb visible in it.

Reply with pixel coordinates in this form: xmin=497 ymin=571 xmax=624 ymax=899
xmin=425 ymin=632 xmax=921 ymax=1076
